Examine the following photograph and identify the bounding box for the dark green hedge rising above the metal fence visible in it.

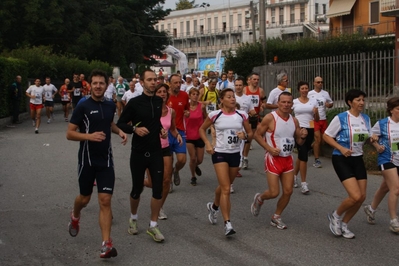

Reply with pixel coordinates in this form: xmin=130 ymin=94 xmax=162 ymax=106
xmin=224 ymin=35 xmax=394 ymax=76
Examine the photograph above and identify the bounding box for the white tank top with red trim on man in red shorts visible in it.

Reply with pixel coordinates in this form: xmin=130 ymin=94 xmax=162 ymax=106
xmin=265 ymin=111 xmax=295 ymax=157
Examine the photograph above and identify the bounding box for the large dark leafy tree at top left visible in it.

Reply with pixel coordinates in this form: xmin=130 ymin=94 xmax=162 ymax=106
xmin=0 ymin=0 xmax=170 ymax=72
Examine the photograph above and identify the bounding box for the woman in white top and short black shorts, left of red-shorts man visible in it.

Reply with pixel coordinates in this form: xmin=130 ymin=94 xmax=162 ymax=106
xmin=199 ymin=89 xmax=252 ymax=236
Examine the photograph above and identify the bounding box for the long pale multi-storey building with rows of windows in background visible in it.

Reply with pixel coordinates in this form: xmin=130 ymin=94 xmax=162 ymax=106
xmin=155 ymin=0 xmax=329 ymax=69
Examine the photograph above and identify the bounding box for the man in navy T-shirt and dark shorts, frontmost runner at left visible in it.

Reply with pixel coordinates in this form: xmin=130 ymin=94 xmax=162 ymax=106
xmin=67 ymin=70 xmax=127 ymax=258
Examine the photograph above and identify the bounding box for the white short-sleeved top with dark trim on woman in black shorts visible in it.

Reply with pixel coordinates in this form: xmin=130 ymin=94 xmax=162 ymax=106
xmin=208 ymin=110 xmax=248 ymax=153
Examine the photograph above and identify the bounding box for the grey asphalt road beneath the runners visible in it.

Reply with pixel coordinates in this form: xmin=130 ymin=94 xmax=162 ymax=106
xmin=0 ymin=113 xmax=399 ymax=265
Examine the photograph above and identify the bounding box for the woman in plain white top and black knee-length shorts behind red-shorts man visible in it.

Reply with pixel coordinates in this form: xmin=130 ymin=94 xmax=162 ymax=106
xmin=292 ymin=81 xmax=319 ymax=194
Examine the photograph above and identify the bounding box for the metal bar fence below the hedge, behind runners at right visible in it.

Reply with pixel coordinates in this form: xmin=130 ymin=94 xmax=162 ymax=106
xmin=253 ymin=51 xmax=395 ymax=119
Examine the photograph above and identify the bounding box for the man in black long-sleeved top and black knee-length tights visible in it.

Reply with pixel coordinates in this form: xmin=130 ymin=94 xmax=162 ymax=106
xmin=117 ymin=70 xmax=167 ymax=242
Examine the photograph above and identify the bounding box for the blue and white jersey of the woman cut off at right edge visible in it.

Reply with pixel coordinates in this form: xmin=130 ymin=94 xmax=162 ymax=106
xmin=371 ymin=117 xmax=399 ymax=166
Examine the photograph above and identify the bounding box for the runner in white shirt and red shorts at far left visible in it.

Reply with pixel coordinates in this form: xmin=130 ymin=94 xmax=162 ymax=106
xmin=26 ymin=79 xmax=44 ymax=134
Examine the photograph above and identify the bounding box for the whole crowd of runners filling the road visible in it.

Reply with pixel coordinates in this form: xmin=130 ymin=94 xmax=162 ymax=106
xmin=7 ymin=70 xmax=399 ymax=258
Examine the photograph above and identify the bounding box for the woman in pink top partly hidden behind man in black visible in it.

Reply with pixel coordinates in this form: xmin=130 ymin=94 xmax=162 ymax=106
xmin=144 ymin=84 xmax=183 ymax=220
